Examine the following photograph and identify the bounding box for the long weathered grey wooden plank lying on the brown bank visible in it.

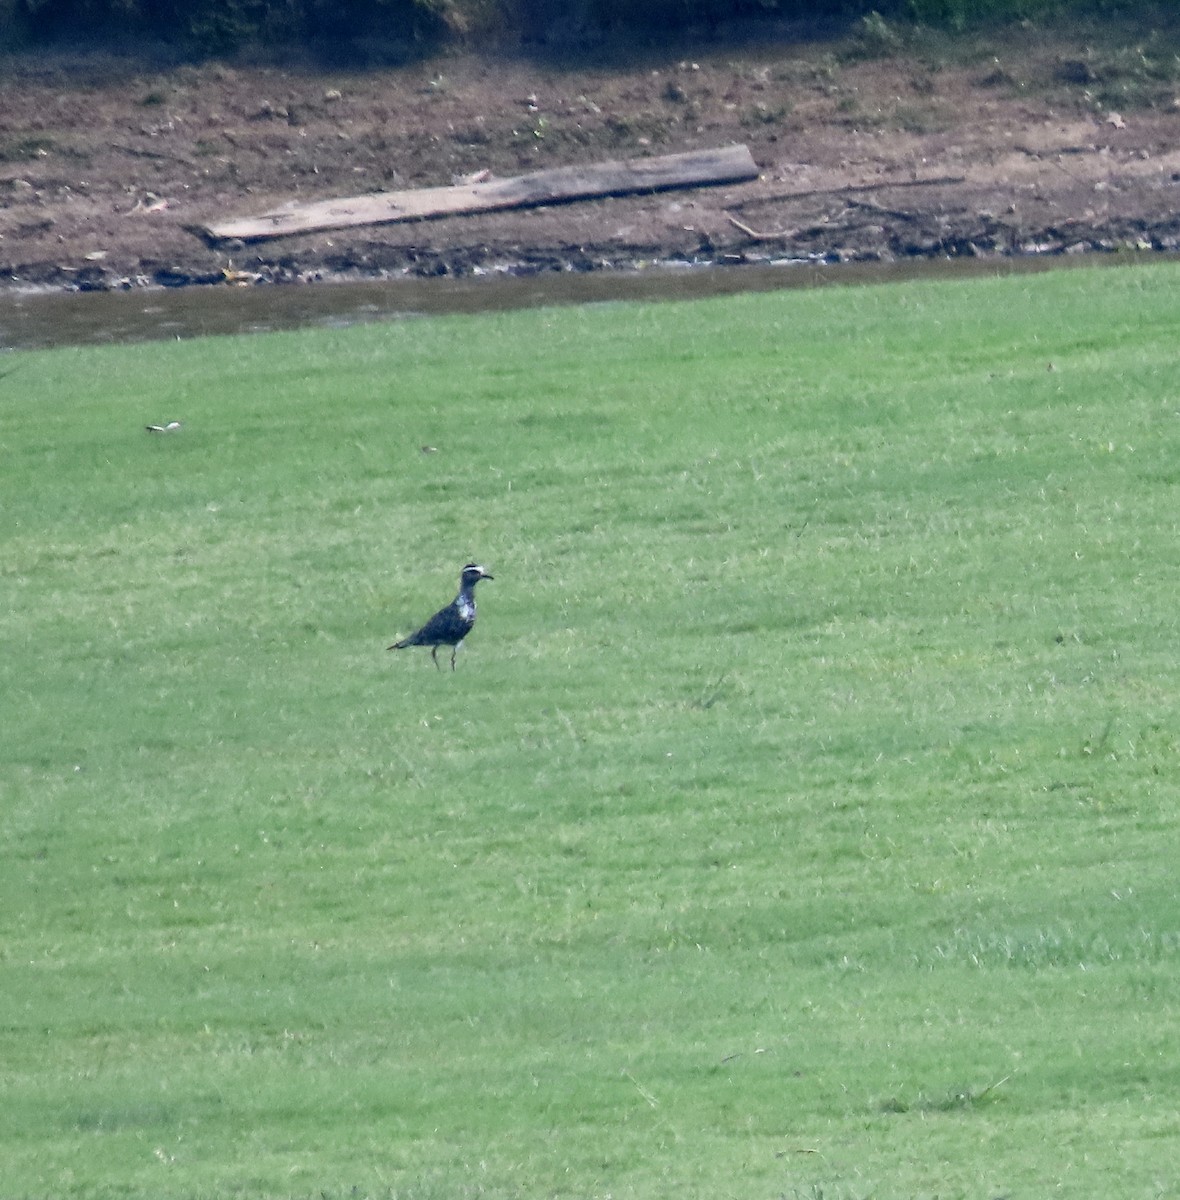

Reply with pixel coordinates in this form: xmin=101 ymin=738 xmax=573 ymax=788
xmin=196 ymin=145 xmax=757 ymax=241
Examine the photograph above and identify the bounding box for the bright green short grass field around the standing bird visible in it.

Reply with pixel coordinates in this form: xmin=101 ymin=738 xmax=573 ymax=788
xmin=0 ymin=264 xmax=1180 ymax=1200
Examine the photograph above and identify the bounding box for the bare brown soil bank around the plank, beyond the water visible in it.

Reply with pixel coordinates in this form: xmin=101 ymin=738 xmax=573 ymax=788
xmin=0 ymin=23 xmax=1180 ymax=289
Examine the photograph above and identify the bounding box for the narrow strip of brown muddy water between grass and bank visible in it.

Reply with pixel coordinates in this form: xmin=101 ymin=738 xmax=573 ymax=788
xmin=0 ymin=256 xmax=1158 ymax=352
